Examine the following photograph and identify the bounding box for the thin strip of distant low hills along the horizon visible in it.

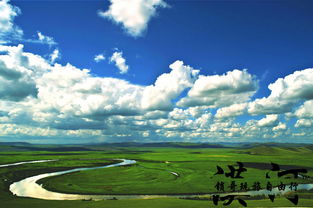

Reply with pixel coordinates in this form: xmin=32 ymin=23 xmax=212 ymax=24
xmin=0 ymin=142 xmax=313 ymax=152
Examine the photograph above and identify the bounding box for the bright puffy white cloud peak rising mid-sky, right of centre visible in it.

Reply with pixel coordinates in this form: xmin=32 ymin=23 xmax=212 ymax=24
xmin=141 ymin=61 xmax=199 ymax=110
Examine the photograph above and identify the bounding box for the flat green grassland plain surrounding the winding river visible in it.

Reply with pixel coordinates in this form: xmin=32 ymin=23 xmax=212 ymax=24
xmin=0 ymin=143 xmax=313 ymax=208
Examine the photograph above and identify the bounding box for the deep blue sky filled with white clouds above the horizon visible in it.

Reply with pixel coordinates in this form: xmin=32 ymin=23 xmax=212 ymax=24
xmin=0 ymin=0 xmax=313 ymax=143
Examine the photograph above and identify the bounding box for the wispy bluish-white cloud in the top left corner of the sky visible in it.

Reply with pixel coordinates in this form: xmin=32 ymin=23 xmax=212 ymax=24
xmin=0 ymin=0 xmax=23 ymax=44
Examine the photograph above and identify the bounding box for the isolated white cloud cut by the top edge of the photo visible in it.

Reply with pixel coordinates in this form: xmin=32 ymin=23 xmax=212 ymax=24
xmin=98 ymin=0 xmax=167 ymax=37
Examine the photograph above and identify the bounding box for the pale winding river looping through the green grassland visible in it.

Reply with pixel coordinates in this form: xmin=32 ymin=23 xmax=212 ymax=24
xmin=4 ymin=159 xmax=313 ymax=200
